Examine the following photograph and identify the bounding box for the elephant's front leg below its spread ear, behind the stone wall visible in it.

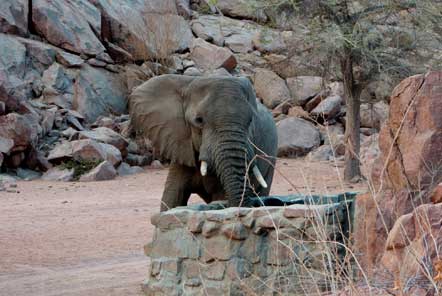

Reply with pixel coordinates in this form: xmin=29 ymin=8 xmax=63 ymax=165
xmin=161 ymin=164 xmax=193 ymax=212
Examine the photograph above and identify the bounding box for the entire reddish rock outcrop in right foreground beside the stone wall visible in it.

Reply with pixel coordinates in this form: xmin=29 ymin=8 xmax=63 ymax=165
xmin=355 ymin=72 xmax=442 ymax=295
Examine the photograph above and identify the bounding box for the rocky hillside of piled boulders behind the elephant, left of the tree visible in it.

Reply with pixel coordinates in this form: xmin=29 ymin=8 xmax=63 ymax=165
xmin=0 ymin=0 xmax=385 ymax=180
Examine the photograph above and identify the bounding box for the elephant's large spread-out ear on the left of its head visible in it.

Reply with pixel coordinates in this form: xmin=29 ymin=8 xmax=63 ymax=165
xmin=129 ymin=75 xmax=195 ymax=166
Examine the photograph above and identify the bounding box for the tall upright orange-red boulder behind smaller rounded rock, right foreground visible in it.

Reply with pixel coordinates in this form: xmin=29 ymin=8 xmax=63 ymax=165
xmin=354 ymin=72 xmax=442 ymax=273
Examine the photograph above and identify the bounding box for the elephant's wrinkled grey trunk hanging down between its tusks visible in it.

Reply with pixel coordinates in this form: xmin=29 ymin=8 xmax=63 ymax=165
xmin=214 ymin=129 xmax=254 ymax=206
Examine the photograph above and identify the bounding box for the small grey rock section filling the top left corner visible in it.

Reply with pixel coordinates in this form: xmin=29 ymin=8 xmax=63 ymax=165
xmin=0 ymin=0 xmax=29 ymax=35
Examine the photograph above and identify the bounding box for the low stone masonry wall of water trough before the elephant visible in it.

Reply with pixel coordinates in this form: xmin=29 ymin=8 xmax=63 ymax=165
xmin=143 ymin=195 xmax=358 ymax=296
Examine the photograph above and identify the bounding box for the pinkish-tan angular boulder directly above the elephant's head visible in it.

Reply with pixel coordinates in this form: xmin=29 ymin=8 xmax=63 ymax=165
xmin=190 ymin=38 xmax=237 ymax=71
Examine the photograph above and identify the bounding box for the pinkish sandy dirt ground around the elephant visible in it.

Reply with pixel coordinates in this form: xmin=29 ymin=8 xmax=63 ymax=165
xmin=0 ymin=159 xmax=366 ymax=296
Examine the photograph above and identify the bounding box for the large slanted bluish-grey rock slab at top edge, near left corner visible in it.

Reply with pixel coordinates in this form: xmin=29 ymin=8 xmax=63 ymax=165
xmin=32 ymin=0 xmax=105 ymax=55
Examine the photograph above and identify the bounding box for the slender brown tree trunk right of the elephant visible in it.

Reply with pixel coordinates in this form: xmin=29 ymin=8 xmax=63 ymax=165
xmin=341 ymin=49 xmax=361 ymax=181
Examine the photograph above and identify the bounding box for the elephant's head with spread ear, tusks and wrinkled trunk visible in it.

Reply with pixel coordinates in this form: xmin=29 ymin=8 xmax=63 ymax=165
xmin=129 ymin=75 xmax=267 ymax=206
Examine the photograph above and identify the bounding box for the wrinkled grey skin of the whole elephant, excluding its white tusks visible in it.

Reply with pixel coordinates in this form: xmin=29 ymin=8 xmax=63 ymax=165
xmin=129 ymin=75 xmax=277 ymax=211
